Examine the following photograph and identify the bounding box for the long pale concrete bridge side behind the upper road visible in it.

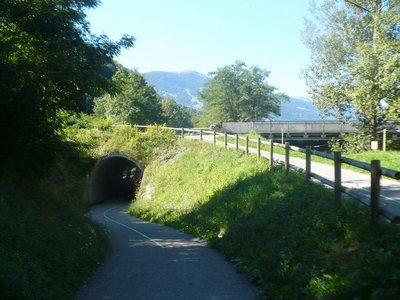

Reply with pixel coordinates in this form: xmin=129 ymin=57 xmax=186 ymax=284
xmin=222 ymin=121 xmax=357 ymax=141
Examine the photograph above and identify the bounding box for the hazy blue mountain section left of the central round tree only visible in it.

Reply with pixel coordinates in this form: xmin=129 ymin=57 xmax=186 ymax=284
xmin=144 ymin=71 xmax=209 ymax=109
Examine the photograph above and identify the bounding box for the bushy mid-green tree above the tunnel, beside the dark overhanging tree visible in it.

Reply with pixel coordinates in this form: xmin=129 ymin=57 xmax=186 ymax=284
xmin=94 ymin=67 xmax=164 ymax=125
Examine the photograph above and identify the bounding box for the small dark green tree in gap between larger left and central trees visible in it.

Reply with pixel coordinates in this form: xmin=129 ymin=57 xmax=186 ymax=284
xmin=161 ymin=98 xmax=193 ymax=128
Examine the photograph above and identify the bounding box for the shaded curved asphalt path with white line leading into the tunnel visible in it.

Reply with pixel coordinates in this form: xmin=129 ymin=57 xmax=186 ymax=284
xmin=76 ymin=202 xmax=257 ymax=300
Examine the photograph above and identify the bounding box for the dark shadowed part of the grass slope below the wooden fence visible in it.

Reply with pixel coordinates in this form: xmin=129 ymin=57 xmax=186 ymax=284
xmin=167 ymin=167 xmax=400 ymax=299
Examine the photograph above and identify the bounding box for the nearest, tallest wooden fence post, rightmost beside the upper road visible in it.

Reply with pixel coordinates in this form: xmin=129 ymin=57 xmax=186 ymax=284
xmin=370 ymin=160 xmax=381 ymax=230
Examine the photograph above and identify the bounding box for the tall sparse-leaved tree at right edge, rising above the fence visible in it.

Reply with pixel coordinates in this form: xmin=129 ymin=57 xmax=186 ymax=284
xmin=303 ymin=0 xmax=400 ymax=137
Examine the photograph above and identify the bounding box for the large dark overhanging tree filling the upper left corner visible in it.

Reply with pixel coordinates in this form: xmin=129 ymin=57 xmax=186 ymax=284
xmin=0 ymin=0 xmax=134 ymax=175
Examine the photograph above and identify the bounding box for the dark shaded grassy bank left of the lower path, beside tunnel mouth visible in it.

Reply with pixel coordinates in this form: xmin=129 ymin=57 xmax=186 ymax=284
xmin=0 ymin=142 xmax=107 ymax=299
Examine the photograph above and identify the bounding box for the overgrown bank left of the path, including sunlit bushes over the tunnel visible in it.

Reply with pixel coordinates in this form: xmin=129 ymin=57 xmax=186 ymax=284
xmin=0 ymin=117 xmax=175 ymax=299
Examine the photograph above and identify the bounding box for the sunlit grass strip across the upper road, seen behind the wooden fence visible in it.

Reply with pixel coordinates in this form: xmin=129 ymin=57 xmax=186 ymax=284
xmin=217 ymin=133 xmax=400 ymax=172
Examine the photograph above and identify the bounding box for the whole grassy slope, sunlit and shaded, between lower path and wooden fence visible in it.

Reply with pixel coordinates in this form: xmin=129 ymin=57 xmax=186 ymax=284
xmin=130 ymin=141 xmax=400 ymax=299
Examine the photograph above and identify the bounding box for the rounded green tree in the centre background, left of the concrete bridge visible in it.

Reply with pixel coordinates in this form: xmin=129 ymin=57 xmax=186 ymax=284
xmin=200 ymin=61 xmax=287 ymax=124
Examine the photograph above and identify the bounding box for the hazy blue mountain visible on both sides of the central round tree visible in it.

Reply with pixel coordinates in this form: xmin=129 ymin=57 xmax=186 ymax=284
xmin=145 ymin=71 xmax=320 ymax=121
